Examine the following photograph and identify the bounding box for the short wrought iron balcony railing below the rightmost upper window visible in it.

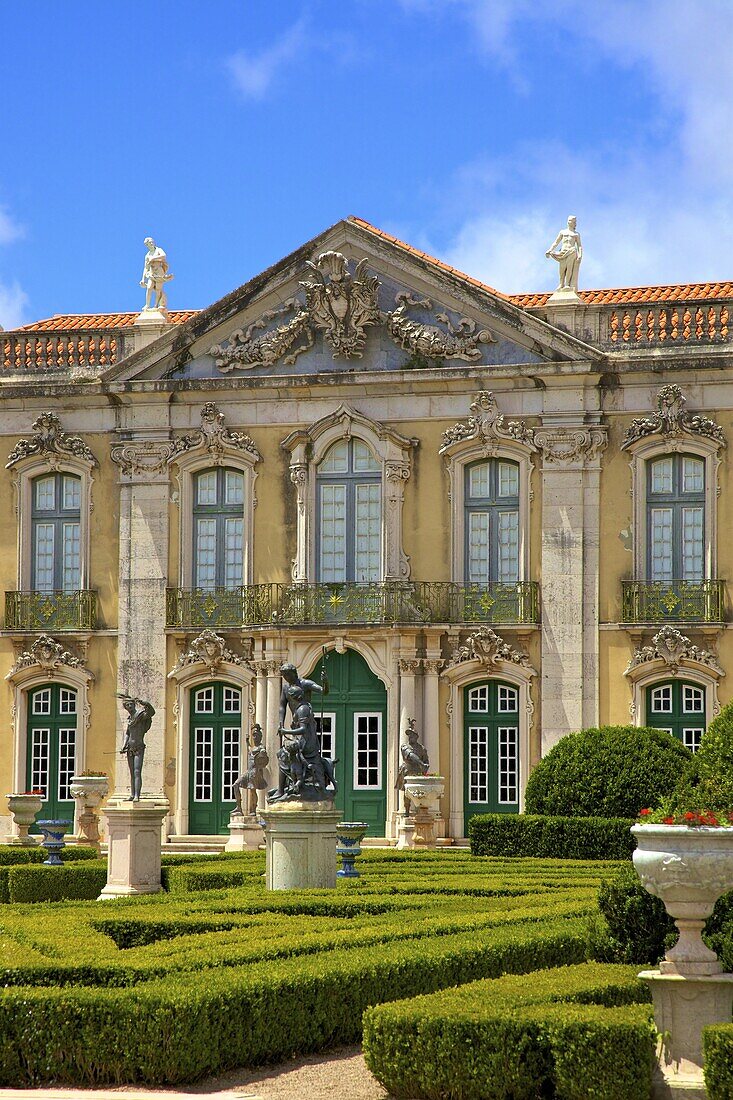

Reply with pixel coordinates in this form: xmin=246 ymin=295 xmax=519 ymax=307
xmin=622 ymin=581 xmax=724 ymax=623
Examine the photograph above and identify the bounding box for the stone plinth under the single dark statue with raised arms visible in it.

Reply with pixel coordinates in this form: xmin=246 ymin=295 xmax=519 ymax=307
xmin=98 ymin=798 xmax=169 ymax=901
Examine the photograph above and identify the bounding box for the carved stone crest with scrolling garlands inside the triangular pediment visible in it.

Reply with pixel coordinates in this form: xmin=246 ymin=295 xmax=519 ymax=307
xmin=209 ymin=252 xmax=496 ymax=374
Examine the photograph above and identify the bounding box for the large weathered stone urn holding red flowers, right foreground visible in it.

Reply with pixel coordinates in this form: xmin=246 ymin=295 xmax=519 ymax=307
xmin=632 ymin=825 xmax=733 ymax=975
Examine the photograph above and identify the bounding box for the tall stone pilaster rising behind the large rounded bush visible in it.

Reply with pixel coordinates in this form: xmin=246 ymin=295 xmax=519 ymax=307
xmin=535 ymin=422 xmax=606 ymax=756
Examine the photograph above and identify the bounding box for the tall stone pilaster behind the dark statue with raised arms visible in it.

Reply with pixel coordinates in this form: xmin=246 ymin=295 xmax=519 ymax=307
xmin=111 ymin=440 xmax=171 ymax=796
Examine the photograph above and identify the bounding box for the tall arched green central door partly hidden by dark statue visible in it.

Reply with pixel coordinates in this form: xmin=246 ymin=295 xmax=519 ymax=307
xmin=308 ymin=649 xmax=386 ymax=836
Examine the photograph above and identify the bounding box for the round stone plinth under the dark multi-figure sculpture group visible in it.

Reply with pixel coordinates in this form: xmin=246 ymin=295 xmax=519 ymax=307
xmin=262 ymin=801 xmax=342 ymax=890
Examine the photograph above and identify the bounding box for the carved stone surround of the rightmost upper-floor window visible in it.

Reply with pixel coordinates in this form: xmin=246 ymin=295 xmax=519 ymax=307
xmin=621 ymin=385 xmax=726 ymax=581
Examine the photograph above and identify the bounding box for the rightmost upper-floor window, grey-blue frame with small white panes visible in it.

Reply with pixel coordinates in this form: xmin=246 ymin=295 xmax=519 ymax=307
xmin=646 ymin=454 xmax=705 ymax=582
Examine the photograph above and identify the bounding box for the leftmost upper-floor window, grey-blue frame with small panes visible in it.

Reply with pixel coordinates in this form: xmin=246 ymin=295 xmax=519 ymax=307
xmin=31 ymin=473 xmax=81 ymax=592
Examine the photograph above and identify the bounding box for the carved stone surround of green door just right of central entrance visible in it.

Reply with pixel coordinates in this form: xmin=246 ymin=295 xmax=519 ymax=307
xmin=440 ymin=628 xmax=537 ymax=837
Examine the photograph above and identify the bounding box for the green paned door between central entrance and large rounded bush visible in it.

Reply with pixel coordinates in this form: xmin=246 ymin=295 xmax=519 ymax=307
xmin=463 ymin=680 xmax=519 ymax=835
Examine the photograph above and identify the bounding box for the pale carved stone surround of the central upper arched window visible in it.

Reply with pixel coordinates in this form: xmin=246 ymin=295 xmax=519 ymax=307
xmin=281 ymin=405 xmax=419 ymax=583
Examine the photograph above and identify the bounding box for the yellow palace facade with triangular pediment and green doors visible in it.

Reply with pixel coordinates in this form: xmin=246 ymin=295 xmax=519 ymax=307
xmin=0 ymin=218 xmax=733 ymax=838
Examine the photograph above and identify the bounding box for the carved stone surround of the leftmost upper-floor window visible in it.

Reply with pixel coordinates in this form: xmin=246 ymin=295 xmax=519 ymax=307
xmin=6 ymin=413 xmax=97 ymax=592
